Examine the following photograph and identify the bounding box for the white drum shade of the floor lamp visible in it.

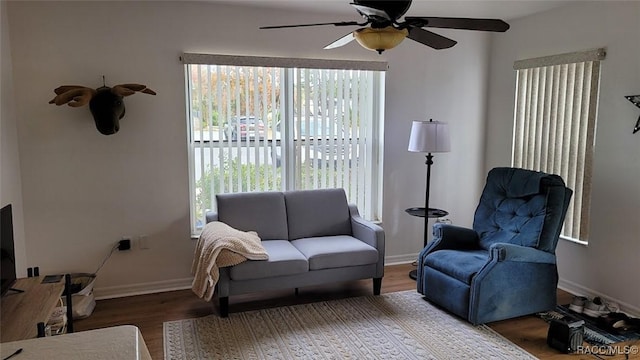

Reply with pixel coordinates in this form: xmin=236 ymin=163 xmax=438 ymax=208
xmin=409 ymin=121 xmax=451 ymax=153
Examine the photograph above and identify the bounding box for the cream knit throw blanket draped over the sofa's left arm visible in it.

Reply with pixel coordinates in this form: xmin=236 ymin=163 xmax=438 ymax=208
xmin=191 ymin=221 xmax=269 ymax=301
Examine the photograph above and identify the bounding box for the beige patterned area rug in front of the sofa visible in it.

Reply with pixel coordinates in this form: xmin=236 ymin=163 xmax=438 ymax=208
xmin=164 ymin=291 xmax=535 ymax=360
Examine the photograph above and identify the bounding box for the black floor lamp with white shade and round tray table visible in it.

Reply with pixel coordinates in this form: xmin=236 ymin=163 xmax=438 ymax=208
xmin=407 ymin=119 xmax=451 ymax=279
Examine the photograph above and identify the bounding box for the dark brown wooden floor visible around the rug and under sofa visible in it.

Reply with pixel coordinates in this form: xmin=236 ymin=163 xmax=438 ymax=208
xmin=74 ymin=264 xmax=640 ymax=360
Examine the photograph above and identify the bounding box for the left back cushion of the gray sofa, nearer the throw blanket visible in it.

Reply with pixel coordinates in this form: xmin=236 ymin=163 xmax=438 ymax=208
xmin=216 ymin=191 xmax=289 ymax=240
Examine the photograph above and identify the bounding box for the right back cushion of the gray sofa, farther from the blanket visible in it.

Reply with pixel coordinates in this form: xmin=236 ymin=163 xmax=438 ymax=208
xmin=284 ymin=189 xmax=351 ymax=240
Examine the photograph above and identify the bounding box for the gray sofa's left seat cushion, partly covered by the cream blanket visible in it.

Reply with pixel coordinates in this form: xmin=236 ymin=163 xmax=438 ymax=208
xmin=229 ymin=240 xmax=309 ymax=280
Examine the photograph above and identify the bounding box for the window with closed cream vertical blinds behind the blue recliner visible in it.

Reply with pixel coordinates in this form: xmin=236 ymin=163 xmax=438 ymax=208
xmin=512 ymin=49 xmax=605 ymax=243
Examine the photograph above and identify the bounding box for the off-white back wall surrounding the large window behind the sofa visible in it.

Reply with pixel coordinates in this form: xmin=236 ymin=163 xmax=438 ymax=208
xmin=3 ymin=1 xmax=489 ymax=296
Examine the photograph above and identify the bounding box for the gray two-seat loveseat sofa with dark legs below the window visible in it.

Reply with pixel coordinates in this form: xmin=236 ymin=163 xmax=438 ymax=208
xmin=207 ymin=189 xmax=384 ymax=317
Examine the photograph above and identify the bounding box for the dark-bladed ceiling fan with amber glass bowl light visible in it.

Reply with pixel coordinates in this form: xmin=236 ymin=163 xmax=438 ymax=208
xmin=260 ymin=0 xmax=509 ymax=54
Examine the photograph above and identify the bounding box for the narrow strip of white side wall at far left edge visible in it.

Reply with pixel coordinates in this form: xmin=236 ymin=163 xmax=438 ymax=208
xmin=0 ymin=1 xmax=27 ymax=277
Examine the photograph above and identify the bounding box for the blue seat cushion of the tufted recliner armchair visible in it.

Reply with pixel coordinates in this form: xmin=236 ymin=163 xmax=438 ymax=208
xmin=424 ymin=250 xmax=489 ymax=285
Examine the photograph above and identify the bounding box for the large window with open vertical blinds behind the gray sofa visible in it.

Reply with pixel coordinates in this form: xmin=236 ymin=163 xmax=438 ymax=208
xmin=182 ymin=54 xmax=386 ymax=232
